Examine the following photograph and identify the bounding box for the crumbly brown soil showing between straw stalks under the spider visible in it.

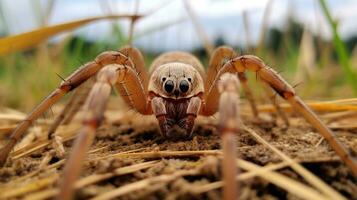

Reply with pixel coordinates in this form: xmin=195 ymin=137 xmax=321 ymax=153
xmin=0 ymin=99 xmax=357 ymax=199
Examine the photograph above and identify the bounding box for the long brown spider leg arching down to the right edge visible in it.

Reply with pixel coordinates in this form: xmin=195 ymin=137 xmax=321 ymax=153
xmin=203 ymin=55 xmax=357 ymax=176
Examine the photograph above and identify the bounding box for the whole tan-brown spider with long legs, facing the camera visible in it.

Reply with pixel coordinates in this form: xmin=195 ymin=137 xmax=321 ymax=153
xmin=0 ymin=46 xmax=357 ymax=199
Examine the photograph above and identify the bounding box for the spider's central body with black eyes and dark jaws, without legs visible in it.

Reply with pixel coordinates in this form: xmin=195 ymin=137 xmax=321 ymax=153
xmin=148 ymin=52 xmax=204 ymax=137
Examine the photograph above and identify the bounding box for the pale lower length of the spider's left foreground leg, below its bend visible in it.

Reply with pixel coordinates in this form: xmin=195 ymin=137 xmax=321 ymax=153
xmin=58 ymin=64 xmax=121 ymax=199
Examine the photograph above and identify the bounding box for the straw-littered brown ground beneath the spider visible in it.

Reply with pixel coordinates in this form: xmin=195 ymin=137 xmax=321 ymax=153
xmin=0 ymin=97 xmax=357 ymax=199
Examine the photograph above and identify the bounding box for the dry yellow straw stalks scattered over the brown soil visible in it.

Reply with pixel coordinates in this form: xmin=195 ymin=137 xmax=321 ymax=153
xmin=0 ymin=99 xmax=357 ymax=199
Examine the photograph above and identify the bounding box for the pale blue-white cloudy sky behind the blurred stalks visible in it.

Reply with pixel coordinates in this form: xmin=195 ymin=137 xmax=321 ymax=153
xmin=0 ymin=0 xmax=357 ymax=51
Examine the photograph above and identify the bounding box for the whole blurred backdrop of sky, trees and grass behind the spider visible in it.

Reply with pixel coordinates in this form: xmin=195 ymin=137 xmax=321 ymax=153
xmin=0 ymin=0 xmax=357 ymax=111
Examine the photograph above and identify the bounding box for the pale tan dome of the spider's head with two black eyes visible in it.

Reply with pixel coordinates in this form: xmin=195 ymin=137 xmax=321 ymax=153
xmin=149 ymin=62 xmax=203 ymax=99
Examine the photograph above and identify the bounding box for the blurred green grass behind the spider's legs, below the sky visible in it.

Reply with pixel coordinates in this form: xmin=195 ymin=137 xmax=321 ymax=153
xmin=0 ymin=5 xmax=357 ymax=111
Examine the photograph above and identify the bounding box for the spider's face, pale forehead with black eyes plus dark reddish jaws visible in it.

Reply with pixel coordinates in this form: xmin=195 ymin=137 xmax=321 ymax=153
xmin=148 ymin=62 xmax=204 ymax=138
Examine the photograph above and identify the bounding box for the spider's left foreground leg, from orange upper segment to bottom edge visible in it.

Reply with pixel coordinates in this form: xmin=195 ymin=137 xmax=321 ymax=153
xmin=57 ymin=49 xmax=152 ymax=199
